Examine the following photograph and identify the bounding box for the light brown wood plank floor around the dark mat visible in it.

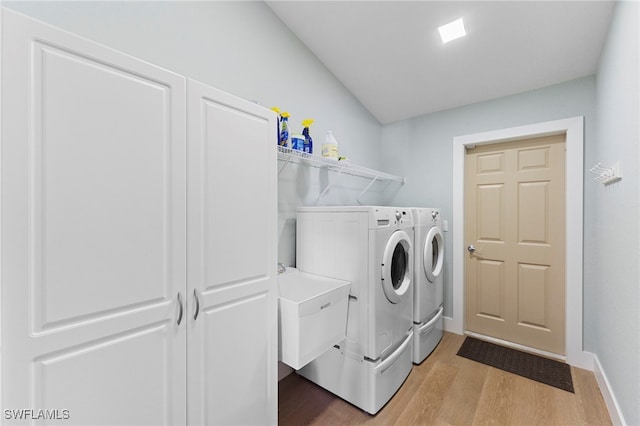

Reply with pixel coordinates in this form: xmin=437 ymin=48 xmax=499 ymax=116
xmin=278 ymin=333 xmax=611 ymax=426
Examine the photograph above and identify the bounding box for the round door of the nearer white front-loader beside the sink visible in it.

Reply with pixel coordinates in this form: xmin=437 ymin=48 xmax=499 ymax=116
xmin=382 ymin=231 xmax=413 ymax=303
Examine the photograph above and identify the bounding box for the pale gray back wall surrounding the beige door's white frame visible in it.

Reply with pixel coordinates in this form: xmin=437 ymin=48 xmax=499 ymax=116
xmin=382 ymin=76 xmax=596 ymax=322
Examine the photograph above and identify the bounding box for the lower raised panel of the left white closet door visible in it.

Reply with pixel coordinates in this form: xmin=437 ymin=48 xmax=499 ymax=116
xmin=32 ymin=322 xmax=172 ymax=425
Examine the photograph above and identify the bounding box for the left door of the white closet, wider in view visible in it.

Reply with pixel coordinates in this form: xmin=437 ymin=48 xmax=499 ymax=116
xmin=1 ymin=9 xmax=186 ymax=425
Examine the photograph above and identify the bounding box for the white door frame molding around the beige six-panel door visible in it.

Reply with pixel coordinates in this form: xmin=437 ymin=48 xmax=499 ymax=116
xmin=444 ymin=116 xmax=593 ymax=370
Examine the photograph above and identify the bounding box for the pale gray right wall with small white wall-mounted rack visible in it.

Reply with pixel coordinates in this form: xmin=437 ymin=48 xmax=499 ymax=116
xmin=585 ymin=1 xmax=640 ymax=425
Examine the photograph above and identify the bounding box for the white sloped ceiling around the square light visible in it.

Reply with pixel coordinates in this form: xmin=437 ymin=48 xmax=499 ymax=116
xmin=267 ymin=0 xmax=614 ymax=124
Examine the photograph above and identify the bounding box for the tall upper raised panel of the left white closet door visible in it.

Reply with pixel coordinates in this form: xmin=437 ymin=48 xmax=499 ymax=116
xmin=30 ymin=43 xmax=173 ymax=331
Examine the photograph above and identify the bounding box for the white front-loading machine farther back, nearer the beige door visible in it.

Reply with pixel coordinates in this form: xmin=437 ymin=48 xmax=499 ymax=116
xmin=411 ymin=208 xmax=444 ymax=364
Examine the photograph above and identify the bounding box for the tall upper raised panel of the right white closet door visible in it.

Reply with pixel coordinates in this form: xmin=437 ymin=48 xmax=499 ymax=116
xmin=199 ymin=98 xmax=277 ymax=290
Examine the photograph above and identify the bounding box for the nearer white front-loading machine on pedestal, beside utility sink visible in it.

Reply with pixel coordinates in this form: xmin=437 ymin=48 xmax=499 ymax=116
xmin=296 ymin=206 xmax=414 ymax=414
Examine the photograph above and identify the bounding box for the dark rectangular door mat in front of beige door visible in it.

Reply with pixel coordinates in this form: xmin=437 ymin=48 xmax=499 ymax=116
xmin=458 ymin=336 xmax=574 ymax=393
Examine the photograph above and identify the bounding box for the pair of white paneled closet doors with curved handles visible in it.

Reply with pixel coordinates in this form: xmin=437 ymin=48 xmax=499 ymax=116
xmin=0 ymin=9 xmax=277 ymax=425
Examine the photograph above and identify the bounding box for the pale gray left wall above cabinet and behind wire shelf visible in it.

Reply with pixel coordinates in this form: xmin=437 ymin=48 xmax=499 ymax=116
xmin=2 ymin=1 xmax=393 ymax=272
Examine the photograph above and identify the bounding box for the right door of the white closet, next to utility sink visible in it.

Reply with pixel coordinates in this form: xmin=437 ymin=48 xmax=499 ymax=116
xmin=187 ymin=80 xmax=278 ymax=425
